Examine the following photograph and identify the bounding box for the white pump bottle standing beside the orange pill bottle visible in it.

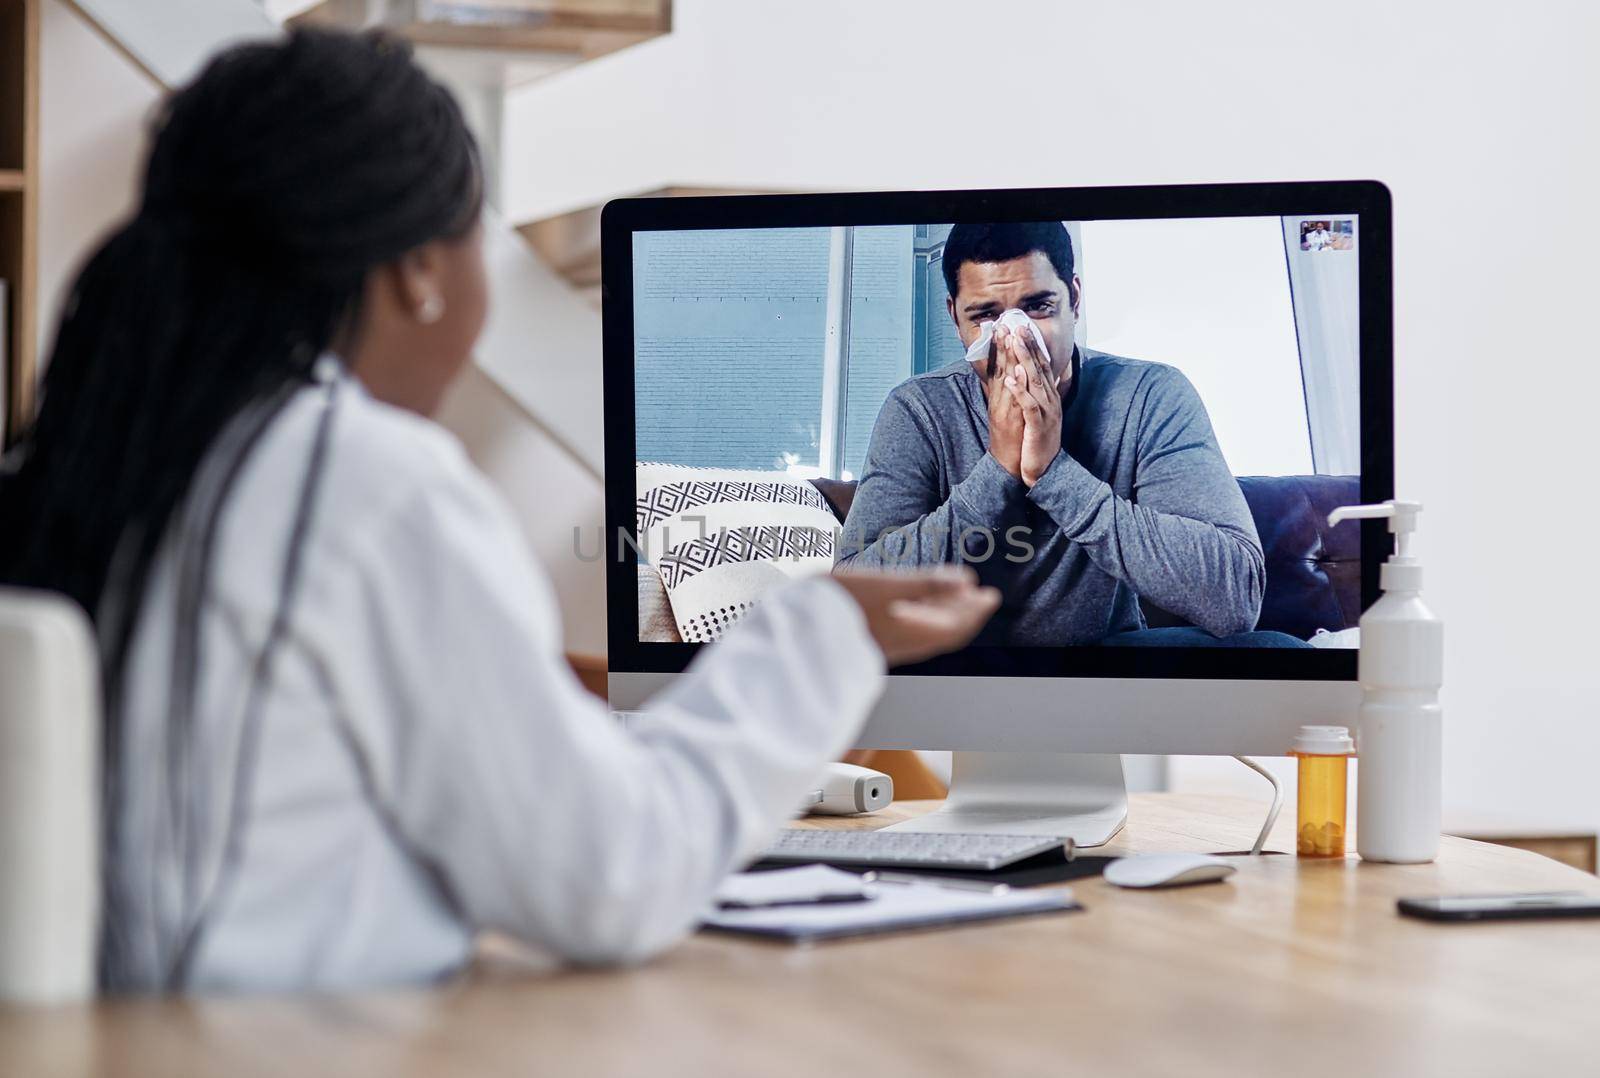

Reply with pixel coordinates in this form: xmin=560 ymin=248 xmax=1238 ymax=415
xmin=1328 ymin=501 xmax=1445 ymax=864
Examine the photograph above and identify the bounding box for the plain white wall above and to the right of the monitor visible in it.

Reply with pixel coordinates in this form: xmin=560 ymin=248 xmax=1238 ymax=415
xmin=506 ymin=0 xmax=1600 ymax=828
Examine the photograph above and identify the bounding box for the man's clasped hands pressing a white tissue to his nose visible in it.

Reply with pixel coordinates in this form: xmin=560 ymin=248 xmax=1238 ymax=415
xmin=973 ymin=326 xmax=1072 ymax=486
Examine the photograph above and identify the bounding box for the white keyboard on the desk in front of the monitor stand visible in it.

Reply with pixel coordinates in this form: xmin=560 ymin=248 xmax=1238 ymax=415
xmin=762 ymin=827 xmax=1067 ymax=870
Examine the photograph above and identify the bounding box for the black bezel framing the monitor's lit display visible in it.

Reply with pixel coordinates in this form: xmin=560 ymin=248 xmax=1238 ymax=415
xmin=600 ymin=179 xmax=1394 ymax=681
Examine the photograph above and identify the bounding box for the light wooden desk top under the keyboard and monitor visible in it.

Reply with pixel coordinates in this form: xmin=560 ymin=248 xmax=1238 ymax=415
xmin=0 ymin=795 xmax=1600 ymax=1078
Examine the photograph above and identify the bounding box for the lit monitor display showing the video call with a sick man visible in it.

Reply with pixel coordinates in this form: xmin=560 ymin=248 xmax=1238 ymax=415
xmin=604 ymin=182 xmax=1389 ymax=669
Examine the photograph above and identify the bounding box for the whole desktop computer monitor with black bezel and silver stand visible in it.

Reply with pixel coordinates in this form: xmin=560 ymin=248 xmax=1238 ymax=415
xmin=602 ymin=181 xmax=1394 ymax=844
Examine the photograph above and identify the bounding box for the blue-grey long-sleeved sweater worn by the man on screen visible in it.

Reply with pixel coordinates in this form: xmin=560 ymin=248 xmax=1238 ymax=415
xmin=838 ymin=350 xmax=1266 ymax=645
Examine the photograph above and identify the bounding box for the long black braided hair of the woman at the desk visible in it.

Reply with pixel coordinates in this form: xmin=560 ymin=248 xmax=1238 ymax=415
xmin=0 ymin=29 xmax=483 ymax=984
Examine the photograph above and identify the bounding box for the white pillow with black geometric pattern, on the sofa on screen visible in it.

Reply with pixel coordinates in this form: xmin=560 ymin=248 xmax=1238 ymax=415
xmin=635 ymin=464 xmax=838 ymax=643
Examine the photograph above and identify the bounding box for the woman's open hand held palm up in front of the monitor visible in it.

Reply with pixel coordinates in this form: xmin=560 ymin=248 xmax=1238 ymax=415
xmin=834 ymin=565 xmax=1000 ymax=667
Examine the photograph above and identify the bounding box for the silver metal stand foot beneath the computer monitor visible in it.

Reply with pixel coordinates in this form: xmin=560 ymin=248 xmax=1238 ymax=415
xmin=885 ymin=752 xmax=1128 ymax=846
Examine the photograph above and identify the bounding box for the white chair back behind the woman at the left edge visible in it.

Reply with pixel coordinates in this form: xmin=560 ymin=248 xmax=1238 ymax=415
xmin=0 ymin=589 xmax=101 ymax=1003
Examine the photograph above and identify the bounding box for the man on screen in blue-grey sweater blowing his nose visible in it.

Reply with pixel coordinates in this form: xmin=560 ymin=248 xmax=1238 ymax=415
xmin=838 ymin=221 xmax=1299 ymax=646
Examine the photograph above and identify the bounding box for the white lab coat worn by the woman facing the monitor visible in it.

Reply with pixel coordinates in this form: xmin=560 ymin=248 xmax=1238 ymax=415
xmin=114 ymin=377 xmax=883 ymax=990
